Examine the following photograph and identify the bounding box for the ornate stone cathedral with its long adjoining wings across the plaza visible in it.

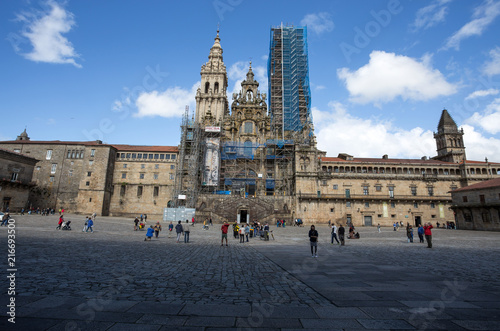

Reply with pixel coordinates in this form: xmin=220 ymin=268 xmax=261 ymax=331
xmin=0 ymin=33 xmax=500 ymax=226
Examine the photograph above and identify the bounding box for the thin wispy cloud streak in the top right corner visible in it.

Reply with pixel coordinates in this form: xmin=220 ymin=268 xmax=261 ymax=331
xmin=442 ymin=0 xmax=500 ymax=51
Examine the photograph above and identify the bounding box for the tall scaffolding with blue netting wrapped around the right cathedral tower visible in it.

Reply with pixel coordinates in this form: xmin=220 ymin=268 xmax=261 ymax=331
xmin=268 ymin=24 xmax=312 ymax=139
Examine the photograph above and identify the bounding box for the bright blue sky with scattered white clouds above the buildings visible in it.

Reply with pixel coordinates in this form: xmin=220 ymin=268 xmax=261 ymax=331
xmin=0 ymin=0 xmax=500 ymax=162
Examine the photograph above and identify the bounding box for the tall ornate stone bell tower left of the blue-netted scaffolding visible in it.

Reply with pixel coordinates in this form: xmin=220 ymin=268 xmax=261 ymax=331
xmin=196 ymin=30 xmax=229 ymax=126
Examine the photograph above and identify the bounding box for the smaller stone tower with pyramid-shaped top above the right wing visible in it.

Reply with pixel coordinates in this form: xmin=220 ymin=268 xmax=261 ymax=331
xmin=434 ymin=109 xmax=465 ymax=163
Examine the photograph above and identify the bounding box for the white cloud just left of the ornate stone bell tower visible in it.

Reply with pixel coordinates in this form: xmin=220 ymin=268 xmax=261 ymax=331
xmin=134 ymin=83 xmax=199 ymax=118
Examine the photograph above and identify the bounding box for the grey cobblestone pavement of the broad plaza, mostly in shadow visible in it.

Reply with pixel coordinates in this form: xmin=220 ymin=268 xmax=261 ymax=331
xmin=0 ymin=215 xmax=500 ymax=330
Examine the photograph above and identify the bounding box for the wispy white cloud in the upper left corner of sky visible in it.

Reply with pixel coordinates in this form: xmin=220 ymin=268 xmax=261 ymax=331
xmin=18 ymin=0 xmax=81 ymax=68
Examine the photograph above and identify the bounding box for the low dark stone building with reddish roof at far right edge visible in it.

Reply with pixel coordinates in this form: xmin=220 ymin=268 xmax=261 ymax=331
xmin=451 ymin=178 xmax=500 ymax=231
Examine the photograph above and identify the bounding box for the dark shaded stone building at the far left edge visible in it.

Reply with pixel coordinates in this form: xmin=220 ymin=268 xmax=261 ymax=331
xmin=0 ymin=149 xmax=38 ymax=212
